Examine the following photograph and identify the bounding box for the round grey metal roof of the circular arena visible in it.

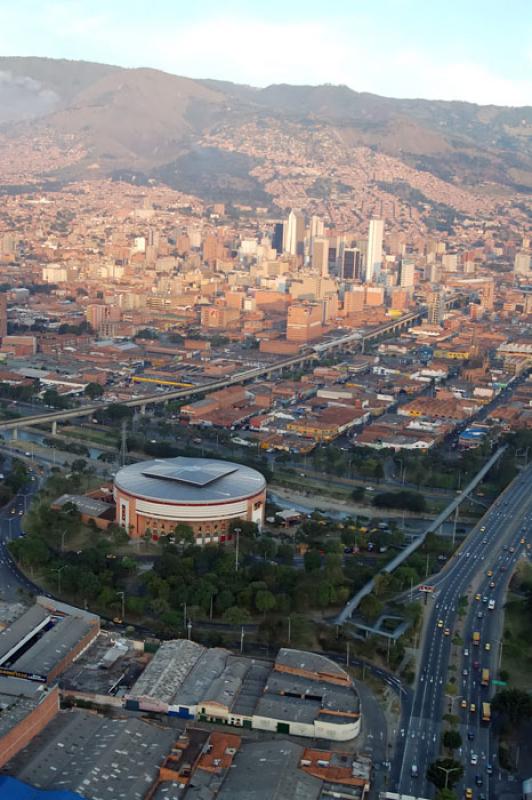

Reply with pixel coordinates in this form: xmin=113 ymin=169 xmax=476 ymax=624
xmin=115 ymin=457 xmax=266 ymax=505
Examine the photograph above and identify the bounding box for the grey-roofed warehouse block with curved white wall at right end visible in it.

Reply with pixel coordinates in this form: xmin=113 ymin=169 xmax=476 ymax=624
xmin=126 ymin=639 xmax=360 ymax=741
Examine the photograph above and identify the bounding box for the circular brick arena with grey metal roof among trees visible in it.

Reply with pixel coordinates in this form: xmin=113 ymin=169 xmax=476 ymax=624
xmin=114 ymin=458 xmax=266 ymax=544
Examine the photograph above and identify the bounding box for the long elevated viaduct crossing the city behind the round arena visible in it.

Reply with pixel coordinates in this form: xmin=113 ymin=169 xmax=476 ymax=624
xmin=0 ymin=298 xmax=455 ymax=438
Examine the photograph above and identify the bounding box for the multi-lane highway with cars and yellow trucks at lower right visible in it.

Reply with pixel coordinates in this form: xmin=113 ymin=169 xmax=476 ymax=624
xmin=391 ymin=468 xmax=532 ymax=797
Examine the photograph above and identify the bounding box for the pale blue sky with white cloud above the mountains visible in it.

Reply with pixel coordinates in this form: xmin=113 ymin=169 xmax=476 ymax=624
xmin=0 ymin=0 xmax=532 ymax=105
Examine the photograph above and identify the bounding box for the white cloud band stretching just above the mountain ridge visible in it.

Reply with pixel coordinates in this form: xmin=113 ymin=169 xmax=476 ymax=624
xmin=0 ymin=8 xmax=532 ymax=105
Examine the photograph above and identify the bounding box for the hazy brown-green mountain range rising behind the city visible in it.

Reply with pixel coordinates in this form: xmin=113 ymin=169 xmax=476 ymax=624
xmin=0 ymin=57 xmax=532 ymax=202
